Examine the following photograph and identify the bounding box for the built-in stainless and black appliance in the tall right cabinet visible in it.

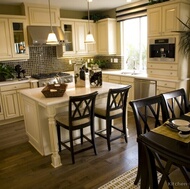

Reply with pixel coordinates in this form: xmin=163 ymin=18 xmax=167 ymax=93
xmin=149 ymin=38 xmax=176 ymax=62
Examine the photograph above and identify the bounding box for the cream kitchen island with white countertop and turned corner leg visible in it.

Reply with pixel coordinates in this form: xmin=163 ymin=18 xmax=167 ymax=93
xmin=20 ymin=82 xmax=129 ymax=168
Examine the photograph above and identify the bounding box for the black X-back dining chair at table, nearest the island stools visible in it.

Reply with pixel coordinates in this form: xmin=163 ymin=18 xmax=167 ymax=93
xmin=129 ymin=95 xmax=167 ymax=185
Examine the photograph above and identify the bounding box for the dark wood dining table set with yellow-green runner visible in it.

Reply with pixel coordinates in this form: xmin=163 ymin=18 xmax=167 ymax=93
xmin=137 ymin=112 xmax=190 ymax=189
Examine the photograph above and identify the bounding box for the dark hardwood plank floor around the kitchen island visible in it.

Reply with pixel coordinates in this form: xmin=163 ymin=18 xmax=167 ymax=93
xmin=0 ymin=113 xmax=137 ymax=189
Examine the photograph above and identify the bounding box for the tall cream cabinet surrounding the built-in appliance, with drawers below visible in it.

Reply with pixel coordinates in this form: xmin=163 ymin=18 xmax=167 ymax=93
xmin=147 ymin=0 xmax=190 ymax=80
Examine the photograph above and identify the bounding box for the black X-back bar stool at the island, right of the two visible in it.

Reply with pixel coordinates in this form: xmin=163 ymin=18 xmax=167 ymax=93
xmin=95 ymin=85 xmax=131 ymax=151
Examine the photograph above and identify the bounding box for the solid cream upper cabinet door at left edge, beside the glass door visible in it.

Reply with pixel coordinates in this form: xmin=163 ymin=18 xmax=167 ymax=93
xmin=0 ymin=18 xmax=12 ymax=59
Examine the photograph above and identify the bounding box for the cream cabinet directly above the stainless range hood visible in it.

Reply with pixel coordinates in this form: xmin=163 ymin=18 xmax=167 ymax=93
xmin=25 ymin=2 xmax=60 ymax=26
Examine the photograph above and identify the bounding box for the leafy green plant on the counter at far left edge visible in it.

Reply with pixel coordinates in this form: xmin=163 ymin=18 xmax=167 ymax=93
xmin=0 ymin=64 xmax=14 ymax=81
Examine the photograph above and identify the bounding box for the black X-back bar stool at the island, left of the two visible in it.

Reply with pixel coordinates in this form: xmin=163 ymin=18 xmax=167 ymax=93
xmin=55 ymin=91 xmax=98 ymax=164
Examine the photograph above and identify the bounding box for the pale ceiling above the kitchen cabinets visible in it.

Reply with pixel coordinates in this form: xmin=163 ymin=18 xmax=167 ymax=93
xmin=0 ymin=0 xmax=141 ymax=11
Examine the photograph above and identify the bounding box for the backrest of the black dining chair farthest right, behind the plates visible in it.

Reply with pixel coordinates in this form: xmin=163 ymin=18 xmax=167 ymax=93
xmin=161 ymin=88 xmax=189 ymax=119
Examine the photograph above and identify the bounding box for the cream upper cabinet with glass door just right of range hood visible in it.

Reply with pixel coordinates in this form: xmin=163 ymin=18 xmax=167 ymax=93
xmin=57 ymin=19 xmax=96 ymax=57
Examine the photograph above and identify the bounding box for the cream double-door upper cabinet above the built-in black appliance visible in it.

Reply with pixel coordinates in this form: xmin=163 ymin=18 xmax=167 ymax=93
xmin=147 ymin=1 xmax=189 ymax=37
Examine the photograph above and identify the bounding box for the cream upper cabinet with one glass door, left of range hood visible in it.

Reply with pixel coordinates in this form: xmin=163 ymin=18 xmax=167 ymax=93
xmin=0 ymin=16 xmax=29 ymax=60
